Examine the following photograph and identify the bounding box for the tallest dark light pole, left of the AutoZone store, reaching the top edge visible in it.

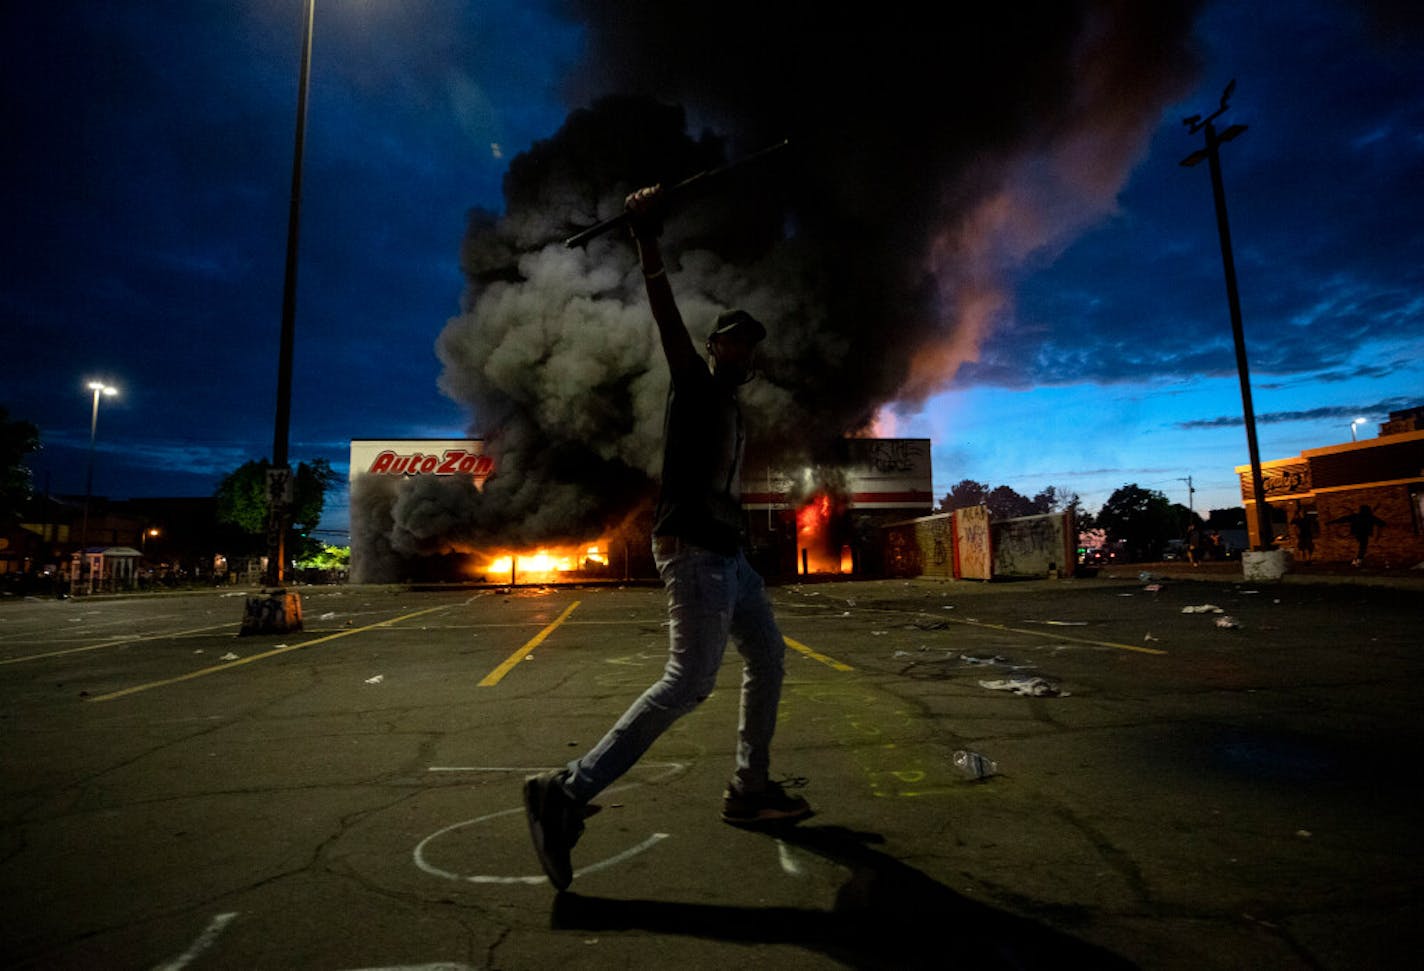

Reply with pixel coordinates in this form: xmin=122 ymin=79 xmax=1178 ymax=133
xmin=266 ymin=0 xmax=316 ymax=587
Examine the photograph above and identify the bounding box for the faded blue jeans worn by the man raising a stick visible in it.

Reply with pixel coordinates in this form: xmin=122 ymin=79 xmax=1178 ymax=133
xmin=565 ymin=537 xmax=786 ymax=803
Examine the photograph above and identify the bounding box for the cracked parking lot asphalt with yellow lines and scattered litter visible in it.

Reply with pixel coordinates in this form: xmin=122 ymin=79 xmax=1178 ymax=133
xmin=0 ymin=571 xmax=1424 ymax=970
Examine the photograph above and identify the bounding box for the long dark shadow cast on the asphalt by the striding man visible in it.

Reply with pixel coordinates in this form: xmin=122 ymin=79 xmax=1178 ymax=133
xmin=553 ymin=826 xmax=1135 ymax=968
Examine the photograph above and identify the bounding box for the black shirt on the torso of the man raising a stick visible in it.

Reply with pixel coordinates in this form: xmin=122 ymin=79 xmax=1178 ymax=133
xmin=652 ymin=364 xmax=746 ymax=555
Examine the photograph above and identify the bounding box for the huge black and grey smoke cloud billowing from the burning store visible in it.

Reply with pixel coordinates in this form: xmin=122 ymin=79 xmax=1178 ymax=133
xmin=352 ymin=0 xmax=1196 ymax=570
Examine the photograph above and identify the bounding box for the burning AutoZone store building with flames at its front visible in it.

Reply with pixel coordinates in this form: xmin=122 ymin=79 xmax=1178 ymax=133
xmin=349 ymin=439 xmax=933 ymax=584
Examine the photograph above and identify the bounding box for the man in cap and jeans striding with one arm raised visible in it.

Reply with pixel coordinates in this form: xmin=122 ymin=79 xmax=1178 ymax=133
xmin=524 ymin=187 xmax=812 ymax=890
